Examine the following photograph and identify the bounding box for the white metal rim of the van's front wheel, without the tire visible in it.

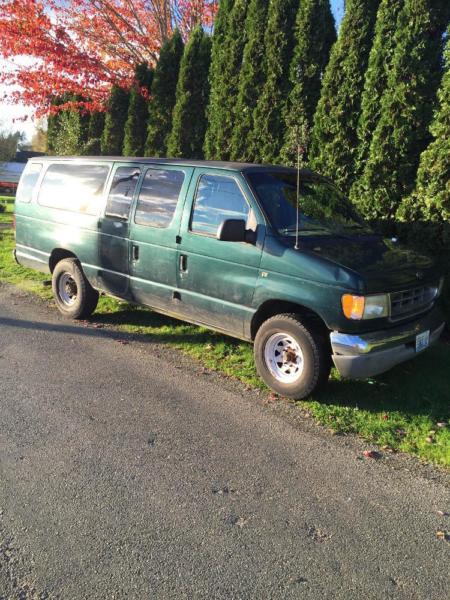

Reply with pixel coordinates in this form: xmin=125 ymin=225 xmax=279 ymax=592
xmin=264 ymin=332 xmax=304 ymax=383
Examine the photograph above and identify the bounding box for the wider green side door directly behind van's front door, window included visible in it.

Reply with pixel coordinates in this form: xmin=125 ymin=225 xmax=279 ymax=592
xmin=130 ymin=164 xmax=193 ymax=314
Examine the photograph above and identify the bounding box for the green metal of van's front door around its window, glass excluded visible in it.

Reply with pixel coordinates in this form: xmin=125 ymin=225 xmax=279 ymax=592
xmin=177 ymin=168 xmax=265 ymax=337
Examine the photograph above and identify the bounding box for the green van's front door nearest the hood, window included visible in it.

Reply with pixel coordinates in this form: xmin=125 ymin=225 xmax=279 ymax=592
xmin=178 ymin=169 xmax=264 ymax=336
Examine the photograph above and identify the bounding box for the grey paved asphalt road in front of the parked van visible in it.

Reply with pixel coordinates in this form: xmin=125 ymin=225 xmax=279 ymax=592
xmin=0 ymin=286 xmax=450 ymax=600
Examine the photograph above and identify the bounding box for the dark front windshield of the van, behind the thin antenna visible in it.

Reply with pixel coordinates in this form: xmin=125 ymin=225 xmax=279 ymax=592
xmin=246 ymin=171 xmax=370 ymax=237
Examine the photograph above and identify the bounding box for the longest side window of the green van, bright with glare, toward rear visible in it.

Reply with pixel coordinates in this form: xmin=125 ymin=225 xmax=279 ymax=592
xmin=38 ymin=163 xmax=109 ymax=215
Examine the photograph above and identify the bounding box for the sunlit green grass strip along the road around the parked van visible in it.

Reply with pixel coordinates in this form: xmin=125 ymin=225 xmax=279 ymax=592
xmin=0 ymin=230 xmax=450 ymax=467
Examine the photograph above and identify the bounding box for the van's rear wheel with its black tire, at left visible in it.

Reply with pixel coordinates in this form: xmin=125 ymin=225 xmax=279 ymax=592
xmin=52 ymin=258 xmax=99 ymax=319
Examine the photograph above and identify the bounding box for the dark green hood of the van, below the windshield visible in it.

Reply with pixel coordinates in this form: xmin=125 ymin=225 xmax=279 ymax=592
xmin=300 ymin=234 xmax=440 ymax=293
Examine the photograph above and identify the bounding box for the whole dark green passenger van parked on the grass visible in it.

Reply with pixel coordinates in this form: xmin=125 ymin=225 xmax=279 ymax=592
xmin=14 ymin=157 xmax=444 ymax=398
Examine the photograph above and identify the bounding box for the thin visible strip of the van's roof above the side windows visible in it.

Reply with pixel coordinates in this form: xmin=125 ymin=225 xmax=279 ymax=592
xmin=30 ymin=156 xmax=313 ymax=174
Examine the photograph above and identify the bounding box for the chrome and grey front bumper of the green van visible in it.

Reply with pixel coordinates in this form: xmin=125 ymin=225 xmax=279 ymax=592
xmin=330 ymin=308 xmax=445 ymax=379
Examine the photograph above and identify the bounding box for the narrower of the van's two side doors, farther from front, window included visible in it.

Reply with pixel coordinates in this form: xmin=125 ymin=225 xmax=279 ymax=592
xmin=98 ymin=164 xmax=141 ymax=297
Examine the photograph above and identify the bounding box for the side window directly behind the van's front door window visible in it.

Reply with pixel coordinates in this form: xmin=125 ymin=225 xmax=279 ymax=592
xmin=134 ymin=169 xmax=184 ymax=227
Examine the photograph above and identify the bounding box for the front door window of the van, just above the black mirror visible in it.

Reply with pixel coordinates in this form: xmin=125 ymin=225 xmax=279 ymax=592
xmin=191 ymin=175 xmax=250 ymax=235
